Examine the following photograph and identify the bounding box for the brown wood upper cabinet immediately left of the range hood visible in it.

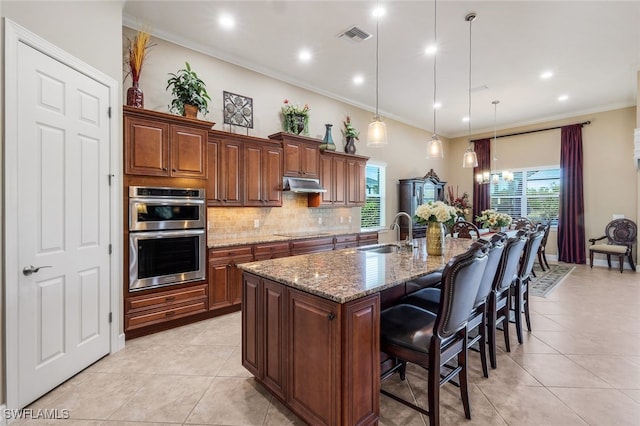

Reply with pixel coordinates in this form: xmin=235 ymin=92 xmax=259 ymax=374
xmin=243 ymin=143 xmax=282 ymax=207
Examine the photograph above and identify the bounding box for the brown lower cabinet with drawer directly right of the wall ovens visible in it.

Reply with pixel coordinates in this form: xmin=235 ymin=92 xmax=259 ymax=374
xmin=208 ymin=246 xmax=253 ymax=310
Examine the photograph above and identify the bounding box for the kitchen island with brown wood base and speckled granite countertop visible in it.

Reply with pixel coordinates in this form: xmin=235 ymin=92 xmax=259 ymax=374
xmin=239 ymin=238 xmax=471 ymax=425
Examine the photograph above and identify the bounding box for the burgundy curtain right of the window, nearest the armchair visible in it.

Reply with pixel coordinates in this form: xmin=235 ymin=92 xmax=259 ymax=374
xmin=558 ymin=124 xmax=587 ymax=264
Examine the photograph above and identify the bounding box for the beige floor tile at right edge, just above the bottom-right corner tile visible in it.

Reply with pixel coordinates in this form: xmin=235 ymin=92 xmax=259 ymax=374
xmin=567 ymin=355 xmax=640 ymax=389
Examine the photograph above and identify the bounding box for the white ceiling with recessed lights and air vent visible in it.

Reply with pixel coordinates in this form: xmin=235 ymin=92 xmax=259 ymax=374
xmin=123 ymin=0 xmax=640 ymax=137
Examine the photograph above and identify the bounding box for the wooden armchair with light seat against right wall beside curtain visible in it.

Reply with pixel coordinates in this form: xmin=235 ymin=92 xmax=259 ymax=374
xmin=589 ymin=219 xmax=638 ymax=273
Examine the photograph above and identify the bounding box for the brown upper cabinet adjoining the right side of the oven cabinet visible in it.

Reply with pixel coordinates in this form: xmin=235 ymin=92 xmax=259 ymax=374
xmin=207 ymin=136 xmax=244 ymax=207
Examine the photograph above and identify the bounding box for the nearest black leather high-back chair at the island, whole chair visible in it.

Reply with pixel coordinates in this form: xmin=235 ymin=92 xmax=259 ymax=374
xmin=380 ymin=243 xmax=488 ymax=426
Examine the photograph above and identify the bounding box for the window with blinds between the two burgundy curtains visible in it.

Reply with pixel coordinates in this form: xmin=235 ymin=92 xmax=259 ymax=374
xmin=490 ymin=168 xmax=560 ymax=226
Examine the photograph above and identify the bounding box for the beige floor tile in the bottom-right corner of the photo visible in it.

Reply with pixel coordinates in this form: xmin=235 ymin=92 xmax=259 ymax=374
xmin=549 ymin=388 xmax=640 ymax=426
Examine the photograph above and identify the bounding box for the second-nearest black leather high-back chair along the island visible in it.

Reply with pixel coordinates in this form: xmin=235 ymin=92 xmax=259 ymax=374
xmin=400 ymin=233 xmax=507 ymax=377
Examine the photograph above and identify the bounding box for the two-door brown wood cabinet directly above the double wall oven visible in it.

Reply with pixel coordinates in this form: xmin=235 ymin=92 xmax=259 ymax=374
xmin=122 ymin=105 xmax=214 ymax=179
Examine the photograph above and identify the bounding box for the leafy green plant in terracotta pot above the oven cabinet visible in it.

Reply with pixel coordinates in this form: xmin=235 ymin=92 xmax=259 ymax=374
xmin=166 ymin=62 xmax=211 ymax=118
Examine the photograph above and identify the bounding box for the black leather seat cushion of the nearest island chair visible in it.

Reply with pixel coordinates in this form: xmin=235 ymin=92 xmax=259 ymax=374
xmin=380 ymin=304 xmax=436 ymax=354
